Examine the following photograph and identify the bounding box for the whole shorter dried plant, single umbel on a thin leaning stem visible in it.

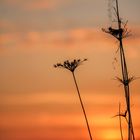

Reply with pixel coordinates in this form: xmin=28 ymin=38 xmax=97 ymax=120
xmin=54 ymin=59 xmax=93 ymax=140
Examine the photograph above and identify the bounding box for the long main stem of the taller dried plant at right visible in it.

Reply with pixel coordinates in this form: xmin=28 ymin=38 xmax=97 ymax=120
xmin=116 ymin=0 xmax=135 ymax=140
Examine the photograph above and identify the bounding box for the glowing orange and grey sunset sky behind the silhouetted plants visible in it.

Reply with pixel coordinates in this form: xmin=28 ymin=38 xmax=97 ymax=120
xmin=0 ymin=0 xmax=140 ymax=140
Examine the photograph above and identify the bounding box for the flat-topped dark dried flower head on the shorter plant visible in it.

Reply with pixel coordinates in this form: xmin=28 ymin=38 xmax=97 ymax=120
xmin=54 ymin=59 xmax=87 ymax=72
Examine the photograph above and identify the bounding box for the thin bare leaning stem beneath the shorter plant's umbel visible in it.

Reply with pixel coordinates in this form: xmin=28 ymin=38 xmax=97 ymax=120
xmin=72 ymin=72 xmax=93 ymax=140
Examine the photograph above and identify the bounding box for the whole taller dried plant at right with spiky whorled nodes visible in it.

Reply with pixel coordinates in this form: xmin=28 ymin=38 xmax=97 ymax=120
xmin=102 ymin=0 xmax=135 ymax=140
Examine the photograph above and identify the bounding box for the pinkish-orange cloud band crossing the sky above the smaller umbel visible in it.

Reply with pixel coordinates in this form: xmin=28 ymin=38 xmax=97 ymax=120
xmin=0 ymin=25 xmax=140 ymax=50
